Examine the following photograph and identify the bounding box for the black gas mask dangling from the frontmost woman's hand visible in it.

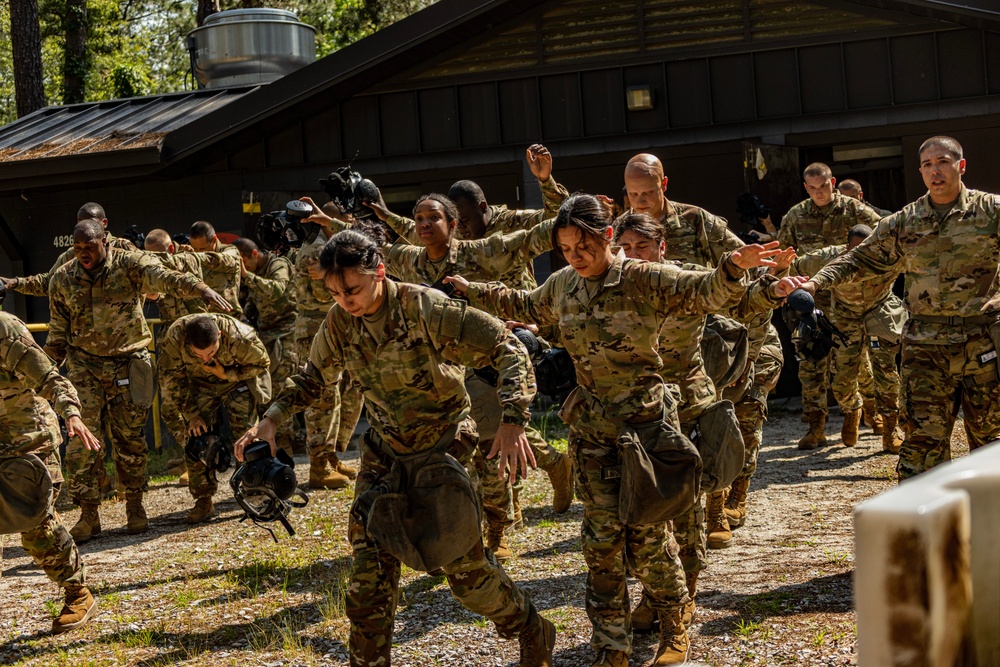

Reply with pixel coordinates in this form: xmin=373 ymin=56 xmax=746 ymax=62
xmin=229 ymin=440 xmax=309 ymax=542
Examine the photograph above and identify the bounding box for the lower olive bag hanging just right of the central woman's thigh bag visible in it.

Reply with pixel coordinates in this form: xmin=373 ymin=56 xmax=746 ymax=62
xmin=695 ymin=401 xmax=746 ymax=493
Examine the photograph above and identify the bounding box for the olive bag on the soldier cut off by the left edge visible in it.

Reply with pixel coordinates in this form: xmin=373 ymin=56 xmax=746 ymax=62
xmin=0 ymin=454 xmax=53 ymax=535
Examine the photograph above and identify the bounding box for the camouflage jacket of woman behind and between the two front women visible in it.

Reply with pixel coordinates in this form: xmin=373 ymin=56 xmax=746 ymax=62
xmin=336 ymin=216 xmax=555 ymax=285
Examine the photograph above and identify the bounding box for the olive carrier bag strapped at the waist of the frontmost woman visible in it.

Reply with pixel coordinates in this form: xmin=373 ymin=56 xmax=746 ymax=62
xmin=351 ymin=424 xmax=482 ymax=572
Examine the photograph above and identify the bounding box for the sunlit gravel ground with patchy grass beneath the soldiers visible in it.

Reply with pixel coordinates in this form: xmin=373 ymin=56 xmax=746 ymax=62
xmin=0 ymin=406 xmax=964 ymax=667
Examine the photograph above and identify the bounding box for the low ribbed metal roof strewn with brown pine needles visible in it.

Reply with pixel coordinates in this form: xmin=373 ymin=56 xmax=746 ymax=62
xmin=0 ymin=86 xmax=256 ymax=162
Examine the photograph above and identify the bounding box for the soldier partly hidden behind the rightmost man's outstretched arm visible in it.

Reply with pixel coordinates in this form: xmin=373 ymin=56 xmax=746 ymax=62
xmin=791 ymin=225 xmax=903 ymax=453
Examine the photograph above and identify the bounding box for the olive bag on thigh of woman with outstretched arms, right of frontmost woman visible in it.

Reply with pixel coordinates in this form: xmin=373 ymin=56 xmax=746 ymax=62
xmin=618 ymin=412 xmax=702 ymax=526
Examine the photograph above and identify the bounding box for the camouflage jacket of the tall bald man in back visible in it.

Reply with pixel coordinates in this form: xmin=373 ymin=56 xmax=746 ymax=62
xmin=648 ymin=200 xmax=744 ymax=267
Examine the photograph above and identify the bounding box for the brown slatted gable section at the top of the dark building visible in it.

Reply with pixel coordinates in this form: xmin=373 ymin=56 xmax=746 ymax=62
xmin=412 ymin=0 xmax=897 ymax=80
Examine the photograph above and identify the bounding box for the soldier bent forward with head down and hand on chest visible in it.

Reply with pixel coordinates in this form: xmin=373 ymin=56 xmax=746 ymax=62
xmin=158 ymin=313 xmax=271 ymax=524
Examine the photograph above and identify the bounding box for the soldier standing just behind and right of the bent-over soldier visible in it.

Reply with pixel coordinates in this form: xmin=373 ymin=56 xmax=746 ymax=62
xmin=233 ymin=243 xmax=299 ymax=454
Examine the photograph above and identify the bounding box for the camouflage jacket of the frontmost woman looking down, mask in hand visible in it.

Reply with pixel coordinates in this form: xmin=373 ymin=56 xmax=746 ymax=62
xmin=266 ymin=280 xmax=535 ymax=454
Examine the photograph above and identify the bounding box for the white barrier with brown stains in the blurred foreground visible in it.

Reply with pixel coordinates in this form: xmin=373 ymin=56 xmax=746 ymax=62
xmin=854 ymin=441 xmax=1000 ymax=667
